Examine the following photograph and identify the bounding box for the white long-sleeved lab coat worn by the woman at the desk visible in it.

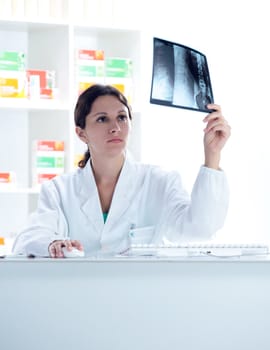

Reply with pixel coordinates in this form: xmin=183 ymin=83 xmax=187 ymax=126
xmin=13 ymin=158 xmax=229 ymax=256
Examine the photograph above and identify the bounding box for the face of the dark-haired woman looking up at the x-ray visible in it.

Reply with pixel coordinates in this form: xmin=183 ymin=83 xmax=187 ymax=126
xmin=76 ymin=95 xmax=131 ymax=157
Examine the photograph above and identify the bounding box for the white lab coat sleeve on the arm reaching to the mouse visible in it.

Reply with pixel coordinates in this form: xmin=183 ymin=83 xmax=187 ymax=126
xmin=12 ymin=181 xmax=68 ymax=257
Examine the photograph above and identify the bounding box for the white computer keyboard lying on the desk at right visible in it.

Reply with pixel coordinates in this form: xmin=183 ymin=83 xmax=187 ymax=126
xmin=129 ymin=243 xmax=269 ymax=257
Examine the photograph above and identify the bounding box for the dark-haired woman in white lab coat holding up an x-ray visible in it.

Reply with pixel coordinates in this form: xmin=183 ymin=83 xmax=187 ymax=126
xmin=13 ymin=85 xmax=230 ymax=258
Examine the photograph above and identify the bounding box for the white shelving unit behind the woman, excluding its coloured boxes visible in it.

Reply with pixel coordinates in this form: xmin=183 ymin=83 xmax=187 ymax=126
xmin=0 ymin=11 xmax=141 ymax=241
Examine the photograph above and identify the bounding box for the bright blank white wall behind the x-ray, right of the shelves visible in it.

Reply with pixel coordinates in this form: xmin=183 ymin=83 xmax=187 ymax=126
xmin=137 ymin=0 xmax=270 ymax=242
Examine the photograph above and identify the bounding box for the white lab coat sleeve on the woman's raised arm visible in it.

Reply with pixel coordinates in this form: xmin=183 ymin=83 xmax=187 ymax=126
xmin=166 ymin=166 xmax=229 ymax=242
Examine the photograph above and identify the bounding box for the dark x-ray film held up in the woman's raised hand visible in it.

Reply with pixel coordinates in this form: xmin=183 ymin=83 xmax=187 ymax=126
xmin=150 ymin=38 xmax=214 ymax=112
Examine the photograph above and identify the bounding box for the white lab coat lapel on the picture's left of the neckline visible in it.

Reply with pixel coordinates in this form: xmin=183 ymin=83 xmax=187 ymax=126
xmin=78 ymin=162 xmax=104 ymax=233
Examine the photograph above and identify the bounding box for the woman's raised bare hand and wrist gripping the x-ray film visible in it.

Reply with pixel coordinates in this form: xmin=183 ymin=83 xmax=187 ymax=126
xmin=203 ymin=104 xmax=231 ymax=169
